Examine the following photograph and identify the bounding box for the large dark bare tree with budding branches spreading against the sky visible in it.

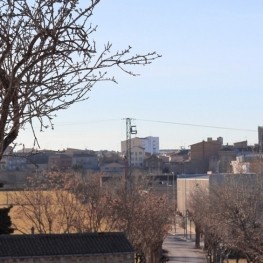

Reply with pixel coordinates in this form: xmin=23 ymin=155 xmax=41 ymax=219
xmin=0 ymin=0 xmax=159 ymax=159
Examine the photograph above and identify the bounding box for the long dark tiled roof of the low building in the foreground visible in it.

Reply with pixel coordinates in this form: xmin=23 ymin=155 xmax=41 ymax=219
xmin=0 ymin=233 xmax=134 ymax=258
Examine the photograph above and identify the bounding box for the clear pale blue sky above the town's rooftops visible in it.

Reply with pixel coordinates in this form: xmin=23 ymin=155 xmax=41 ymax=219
xmin=17 ymin=0 xmax=263 ymax=151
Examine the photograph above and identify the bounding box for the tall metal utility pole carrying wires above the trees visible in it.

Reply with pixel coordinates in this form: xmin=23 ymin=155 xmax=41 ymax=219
xmin=125 ymin=118 xmax=137 ymax=194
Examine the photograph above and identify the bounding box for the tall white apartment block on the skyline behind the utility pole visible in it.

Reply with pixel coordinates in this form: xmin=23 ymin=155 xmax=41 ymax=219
xmin=121 ymin=136 xmax=160 ymax=154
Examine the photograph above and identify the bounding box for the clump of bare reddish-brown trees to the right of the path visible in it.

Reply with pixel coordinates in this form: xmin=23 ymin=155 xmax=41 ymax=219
xmin=191 ymin=175 xmax=263 ymax=263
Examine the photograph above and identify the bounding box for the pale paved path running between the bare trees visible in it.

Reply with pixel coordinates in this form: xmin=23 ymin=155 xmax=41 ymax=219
xmin=163 ymin=229 xmax=207 ymax=263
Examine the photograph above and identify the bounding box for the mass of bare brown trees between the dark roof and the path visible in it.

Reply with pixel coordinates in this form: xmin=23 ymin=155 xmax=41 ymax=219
xmin=9 ymin=172 xmax=172 ymax=263
